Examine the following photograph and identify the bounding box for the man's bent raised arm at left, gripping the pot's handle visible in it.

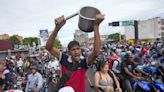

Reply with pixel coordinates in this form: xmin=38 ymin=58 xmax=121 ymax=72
xmin=46 ymin=16 xmax=66 ymax=58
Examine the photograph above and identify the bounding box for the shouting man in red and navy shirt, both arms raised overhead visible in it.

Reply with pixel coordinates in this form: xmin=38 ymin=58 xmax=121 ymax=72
xmin=46 ymin=14 xmax=104 ymax=92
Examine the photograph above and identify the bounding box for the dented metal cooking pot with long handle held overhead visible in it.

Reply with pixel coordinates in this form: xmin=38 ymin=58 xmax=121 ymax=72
xmin=55 ymin=6 xmax=101 ymax=32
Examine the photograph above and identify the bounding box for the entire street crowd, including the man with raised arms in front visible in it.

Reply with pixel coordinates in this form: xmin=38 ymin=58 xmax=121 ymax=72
xmin=0 ymin=14 xmax=164 ymax=92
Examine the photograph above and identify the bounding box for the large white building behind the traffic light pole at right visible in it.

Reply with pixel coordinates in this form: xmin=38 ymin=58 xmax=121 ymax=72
xmin=125 ymin=17 xmax=164 ymax=40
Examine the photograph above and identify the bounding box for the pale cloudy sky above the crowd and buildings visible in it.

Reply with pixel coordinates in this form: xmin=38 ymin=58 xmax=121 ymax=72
xmin=0 ymin=0 xmax=164 ymax=44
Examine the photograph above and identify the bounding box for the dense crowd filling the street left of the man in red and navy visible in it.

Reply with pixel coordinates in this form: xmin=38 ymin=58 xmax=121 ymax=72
xmin=0 ymin=50 xmax=60 ymax=92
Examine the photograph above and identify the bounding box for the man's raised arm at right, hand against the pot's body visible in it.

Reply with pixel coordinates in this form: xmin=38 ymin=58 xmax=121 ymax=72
xmin=88 ymin=14 xmax=104 ymax=66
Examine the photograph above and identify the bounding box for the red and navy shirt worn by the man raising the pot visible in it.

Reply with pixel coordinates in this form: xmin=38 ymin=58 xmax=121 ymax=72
xmin=60 ymin=54 xmax=87 ymax=92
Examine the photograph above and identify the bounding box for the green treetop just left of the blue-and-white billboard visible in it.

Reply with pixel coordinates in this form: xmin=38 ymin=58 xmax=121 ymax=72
xmin=23 ymin=37 xmax=39 ymax=46
